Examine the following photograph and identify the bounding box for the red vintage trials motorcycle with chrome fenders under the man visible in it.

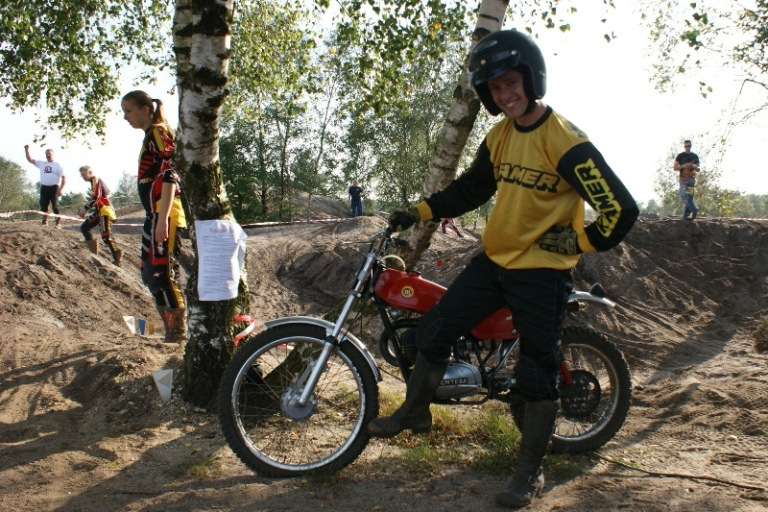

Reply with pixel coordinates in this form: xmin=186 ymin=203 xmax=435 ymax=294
xmin=218 ymin=228 xmax=632 ymax=477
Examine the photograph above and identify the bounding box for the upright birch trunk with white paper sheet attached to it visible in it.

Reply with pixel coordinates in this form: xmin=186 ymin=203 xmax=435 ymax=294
xmin=173 ymin=0 xmax=248 ymax=407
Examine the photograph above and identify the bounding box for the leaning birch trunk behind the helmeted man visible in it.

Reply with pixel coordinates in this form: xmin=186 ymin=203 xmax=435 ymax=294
xmin=403 ymin=0 xmax=509 ymax=266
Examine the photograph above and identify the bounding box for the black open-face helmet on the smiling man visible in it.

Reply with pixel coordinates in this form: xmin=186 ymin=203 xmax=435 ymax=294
xmin=469 ymin=30 xmax=547 ymax=116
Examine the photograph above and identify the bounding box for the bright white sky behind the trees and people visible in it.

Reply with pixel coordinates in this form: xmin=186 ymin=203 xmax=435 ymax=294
xmin=0 ymin=2 xmax=768 ymax=203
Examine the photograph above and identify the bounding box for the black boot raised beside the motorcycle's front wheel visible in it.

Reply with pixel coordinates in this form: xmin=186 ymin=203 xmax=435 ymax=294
xmin=368 ymin=353 xmax=448 ymax=438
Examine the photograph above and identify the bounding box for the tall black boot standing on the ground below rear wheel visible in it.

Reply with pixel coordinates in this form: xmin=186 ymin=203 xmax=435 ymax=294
xmin=496 ymin=400 xmax=558 ymax=508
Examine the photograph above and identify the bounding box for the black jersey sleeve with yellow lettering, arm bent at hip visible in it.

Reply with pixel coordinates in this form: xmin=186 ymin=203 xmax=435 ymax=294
xmin=557 ymin=142 xmax=640 ymax=252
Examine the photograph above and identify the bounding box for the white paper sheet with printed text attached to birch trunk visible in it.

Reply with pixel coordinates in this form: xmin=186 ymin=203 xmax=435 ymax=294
xmin=195 ymin=220 xmax=248 ymax=301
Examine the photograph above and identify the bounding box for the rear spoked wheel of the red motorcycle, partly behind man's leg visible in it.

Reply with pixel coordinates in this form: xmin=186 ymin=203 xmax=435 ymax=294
xmin=511 ymin=326 xmax=632 ymax=453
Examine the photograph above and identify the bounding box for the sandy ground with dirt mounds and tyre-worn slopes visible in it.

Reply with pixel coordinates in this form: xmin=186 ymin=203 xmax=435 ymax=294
xmin=0 ymin=209 xmax=768 ymax=512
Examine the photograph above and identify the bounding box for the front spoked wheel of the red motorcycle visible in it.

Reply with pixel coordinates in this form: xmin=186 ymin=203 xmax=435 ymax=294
xmin=218 ymin=323 xmax=379 ymax=477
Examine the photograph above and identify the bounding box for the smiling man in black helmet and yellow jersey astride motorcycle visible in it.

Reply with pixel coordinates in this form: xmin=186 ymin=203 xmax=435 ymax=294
xmin=368 ymin=30 xmax=638 ymax=507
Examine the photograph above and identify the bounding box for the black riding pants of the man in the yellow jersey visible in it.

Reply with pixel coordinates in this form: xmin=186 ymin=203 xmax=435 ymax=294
xmin=416 ymin=253 xmax=572 ymax=401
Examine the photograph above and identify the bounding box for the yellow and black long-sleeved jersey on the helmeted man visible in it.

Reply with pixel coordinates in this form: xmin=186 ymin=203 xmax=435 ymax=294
xmin=417 ymin=107 xmax=639 ymax=269
